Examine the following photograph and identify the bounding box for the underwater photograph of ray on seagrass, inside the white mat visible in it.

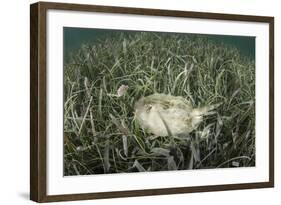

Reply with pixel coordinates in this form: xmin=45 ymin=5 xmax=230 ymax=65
xmin=63 ymin=27 xmax=256 ymax=176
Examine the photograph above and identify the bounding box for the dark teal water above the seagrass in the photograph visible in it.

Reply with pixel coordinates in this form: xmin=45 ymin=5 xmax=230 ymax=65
xmin=63 ymin=27 xmax=255 ymax=62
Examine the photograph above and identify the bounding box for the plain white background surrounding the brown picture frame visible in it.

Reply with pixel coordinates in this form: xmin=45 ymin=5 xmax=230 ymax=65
xmin=0 ymin=0 xmax=281 ymax=205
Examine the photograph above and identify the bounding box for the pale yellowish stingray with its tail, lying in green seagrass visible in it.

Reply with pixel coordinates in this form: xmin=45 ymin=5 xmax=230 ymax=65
xmin=135 ymin=93 xmax=216 ymax=136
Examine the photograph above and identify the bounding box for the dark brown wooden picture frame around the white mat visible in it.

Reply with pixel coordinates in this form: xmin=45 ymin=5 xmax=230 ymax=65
xmin=30 ymin=2 xmax=274 ymax=202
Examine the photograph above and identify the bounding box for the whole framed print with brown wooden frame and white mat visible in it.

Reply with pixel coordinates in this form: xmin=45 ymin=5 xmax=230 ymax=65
xmin=30 ymin=2 xmax=274 ymax=202
